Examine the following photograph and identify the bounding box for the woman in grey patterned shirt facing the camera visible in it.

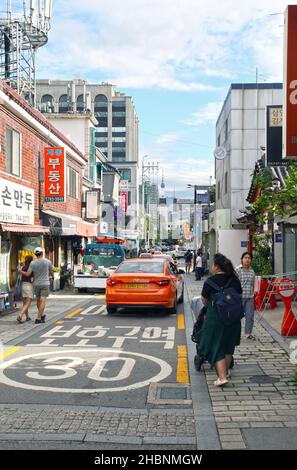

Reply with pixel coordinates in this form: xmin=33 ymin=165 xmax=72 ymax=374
xmin=236 ymin=251 xmax=256 ymax=341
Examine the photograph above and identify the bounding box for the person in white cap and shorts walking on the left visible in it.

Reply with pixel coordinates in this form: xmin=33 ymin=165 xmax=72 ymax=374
xmin=19 ymin=247 xmax=54 ymax=324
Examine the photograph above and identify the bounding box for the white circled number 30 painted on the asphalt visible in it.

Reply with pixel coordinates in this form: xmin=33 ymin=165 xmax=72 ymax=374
xmin=0 ymin=348 xmax=172 ymax=393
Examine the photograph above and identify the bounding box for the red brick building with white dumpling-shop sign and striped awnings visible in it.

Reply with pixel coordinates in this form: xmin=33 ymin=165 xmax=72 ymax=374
xmin=0 ymin=80 xmax=97 ymax=302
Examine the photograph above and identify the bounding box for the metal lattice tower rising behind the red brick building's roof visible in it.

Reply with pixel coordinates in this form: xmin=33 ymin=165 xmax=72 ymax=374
xmin=0 ymin=0 xmax=51 ymax=106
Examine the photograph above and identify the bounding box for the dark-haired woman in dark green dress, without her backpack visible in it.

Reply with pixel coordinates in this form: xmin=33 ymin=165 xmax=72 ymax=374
xmin=198 ymin=253 xmax=242 ymax=387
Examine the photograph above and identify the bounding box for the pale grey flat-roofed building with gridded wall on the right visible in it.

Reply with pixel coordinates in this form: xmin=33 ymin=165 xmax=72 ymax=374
xmin=216 ymin=84 xmax=283 ymax=228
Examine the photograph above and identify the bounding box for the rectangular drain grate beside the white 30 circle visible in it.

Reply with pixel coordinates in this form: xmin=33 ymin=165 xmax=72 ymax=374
xmin=147 ymin=383 xmax=192 ymax=405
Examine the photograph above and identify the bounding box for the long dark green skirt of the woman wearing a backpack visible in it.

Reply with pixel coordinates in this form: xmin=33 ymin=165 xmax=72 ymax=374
xmin=197 ymin=296 xmax=241 ymax=365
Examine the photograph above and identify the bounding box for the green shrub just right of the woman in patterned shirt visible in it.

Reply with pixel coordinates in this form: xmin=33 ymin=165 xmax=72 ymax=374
xmin=252 ymin=234 xmax=273 ymax=276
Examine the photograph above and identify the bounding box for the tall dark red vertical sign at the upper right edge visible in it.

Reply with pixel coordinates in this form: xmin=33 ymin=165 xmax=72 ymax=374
xmin=283 ymin=5 xmax=297 ymax=158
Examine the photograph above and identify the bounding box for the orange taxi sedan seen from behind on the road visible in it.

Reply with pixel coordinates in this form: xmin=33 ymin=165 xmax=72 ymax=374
xmin=106 ymin=258 xmax=184 ymax=314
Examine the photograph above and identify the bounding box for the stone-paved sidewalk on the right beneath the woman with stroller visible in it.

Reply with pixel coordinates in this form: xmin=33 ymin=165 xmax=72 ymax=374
xmin=185 ymin=273 xmax=297 ymax=449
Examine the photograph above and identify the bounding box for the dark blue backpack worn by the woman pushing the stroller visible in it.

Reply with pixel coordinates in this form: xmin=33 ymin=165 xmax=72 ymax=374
xmin=207 ymin=278 xmax=244 ymax=326
